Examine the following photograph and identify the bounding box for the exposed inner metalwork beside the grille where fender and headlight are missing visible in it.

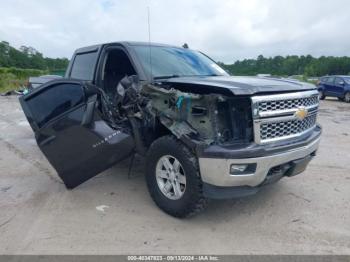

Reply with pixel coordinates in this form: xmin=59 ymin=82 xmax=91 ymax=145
xmin=142 ymin=85 xmax=253 ymax=148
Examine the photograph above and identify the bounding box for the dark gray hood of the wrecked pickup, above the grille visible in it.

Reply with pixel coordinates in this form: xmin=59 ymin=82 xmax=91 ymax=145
xmin=161 ymin=76 xmax=316 ymax=95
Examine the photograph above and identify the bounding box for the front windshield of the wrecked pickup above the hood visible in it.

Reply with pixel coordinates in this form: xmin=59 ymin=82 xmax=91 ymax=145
xmin=135 ymin=46 xmax=228 ymax=79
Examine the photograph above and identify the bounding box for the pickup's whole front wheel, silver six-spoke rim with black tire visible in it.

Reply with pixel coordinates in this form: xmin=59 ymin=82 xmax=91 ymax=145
xmin=146 ymin=136 xmax=207 ymax=218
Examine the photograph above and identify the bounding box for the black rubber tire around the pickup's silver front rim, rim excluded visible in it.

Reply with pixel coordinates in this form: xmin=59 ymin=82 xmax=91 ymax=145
xmin=146 ymin=136 xmax=208 ymax=218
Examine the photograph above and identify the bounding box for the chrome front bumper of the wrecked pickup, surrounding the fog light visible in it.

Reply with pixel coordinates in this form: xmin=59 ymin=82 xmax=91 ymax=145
xmin=199 ymin=129 xmax=321 ymax=198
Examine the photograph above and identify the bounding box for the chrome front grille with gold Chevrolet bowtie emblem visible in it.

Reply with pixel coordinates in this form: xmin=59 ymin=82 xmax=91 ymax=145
xmin=252 ymin=91 xmax=319 ymax=144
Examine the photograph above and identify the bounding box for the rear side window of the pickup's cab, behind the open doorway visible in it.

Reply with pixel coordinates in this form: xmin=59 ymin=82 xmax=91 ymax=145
xmin=70 ymin=52 xmax=97 ymax=81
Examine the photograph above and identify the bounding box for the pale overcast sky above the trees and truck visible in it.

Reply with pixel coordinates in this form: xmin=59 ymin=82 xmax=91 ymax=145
xmin=0 ymin=0 xmax=350 ymax=63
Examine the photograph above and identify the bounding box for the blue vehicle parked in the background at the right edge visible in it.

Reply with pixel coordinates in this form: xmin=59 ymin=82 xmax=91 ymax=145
xmin=317 ymin=75 xmax=350 ymax=103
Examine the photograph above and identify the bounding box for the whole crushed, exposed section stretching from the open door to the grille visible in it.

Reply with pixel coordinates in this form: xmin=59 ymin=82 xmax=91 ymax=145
xmin=97 ymin=76 xmax=253 ymax=154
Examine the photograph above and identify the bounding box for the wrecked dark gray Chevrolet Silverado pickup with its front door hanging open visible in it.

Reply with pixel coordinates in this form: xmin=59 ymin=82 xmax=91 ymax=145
xmin=20 ymin=42 xmax=321 ymax=217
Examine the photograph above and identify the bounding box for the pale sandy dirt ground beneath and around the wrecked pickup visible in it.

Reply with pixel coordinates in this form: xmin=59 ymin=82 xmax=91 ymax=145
xmin=0 ymin=97 xmax=350 ymax=254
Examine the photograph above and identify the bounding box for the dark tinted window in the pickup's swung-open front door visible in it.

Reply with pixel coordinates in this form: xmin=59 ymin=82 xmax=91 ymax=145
xmin=27 ymin=84 xmax=84 ymax=127
